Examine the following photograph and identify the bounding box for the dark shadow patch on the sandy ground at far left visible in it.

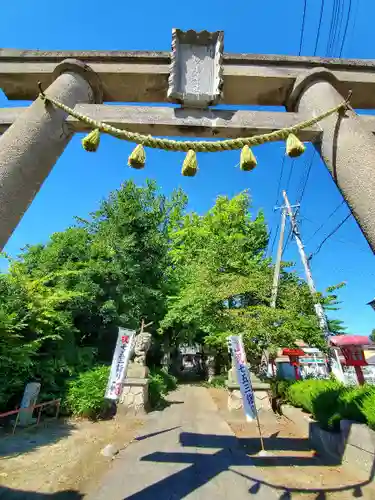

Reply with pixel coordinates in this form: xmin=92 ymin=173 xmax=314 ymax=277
xmin=0 ymin=420 xmax=75 ymax=458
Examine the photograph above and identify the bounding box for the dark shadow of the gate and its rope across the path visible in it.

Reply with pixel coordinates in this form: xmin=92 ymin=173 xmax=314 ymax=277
xmin=124 ymin=432 xmax=375 ymax=500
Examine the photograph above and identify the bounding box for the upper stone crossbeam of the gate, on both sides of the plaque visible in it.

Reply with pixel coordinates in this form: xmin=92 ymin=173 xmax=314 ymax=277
xmin=0 ymin=49 xmax=375 ymax=109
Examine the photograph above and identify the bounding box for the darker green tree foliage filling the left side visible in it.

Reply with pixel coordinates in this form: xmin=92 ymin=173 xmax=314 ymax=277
xmin=0 ymin=182 xmax=186 ymax=408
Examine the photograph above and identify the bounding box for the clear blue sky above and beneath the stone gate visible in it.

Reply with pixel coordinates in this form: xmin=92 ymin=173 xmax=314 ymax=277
xmin=0 ymin=0 xmax=375 ymax=334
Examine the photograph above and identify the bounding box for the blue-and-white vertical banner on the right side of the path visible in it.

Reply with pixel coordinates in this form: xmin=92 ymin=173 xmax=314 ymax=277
xmin=229 ymin=335 xmax=257 ymax=421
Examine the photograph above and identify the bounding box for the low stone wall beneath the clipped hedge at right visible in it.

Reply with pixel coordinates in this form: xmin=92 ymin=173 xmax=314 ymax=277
xmin=281 ymin=405 xmax=375 ymax=475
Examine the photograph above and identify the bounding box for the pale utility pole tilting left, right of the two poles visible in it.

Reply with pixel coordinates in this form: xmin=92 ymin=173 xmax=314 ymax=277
xmin=283 ymin=191 xmax=343 ymax=376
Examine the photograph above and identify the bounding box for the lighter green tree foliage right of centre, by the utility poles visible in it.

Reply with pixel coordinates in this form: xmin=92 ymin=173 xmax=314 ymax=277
xmin=161 ymin=192 xmax=346 ymax=361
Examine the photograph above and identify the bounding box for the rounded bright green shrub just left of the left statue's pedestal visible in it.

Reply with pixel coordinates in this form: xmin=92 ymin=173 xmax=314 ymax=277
xmin=66 ymin=366 xmax=111 ymax=420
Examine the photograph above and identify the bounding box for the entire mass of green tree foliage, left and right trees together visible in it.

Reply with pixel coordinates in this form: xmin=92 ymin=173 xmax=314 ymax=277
xmin=0 ymin=182 xmax=346 ymax=410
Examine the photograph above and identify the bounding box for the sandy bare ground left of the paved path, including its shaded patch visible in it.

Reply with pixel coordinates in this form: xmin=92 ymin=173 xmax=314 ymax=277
xmin=0 ymin=417 xmax=142 ymax=498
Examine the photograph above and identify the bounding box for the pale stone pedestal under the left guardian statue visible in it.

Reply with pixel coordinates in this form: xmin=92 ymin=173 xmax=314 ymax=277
xmin=118 ymin=363 xmax=148 ymax=415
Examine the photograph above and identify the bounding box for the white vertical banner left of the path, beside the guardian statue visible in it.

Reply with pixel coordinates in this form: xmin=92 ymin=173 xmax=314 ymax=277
xmin=104 ymin=328 xmax=135 ymax=400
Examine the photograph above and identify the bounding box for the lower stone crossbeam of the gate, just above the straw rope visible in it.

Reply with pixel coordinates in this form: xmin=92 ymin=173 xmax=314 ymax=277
xmin=0 ymin=104 xmax=328 ymax=142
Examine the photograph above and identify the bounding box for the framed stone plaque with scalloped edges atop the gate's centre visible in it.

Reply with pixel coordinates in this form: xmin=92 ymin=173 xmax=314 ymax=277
xmin=168 ymin=29 xmax=224 ymax=109
